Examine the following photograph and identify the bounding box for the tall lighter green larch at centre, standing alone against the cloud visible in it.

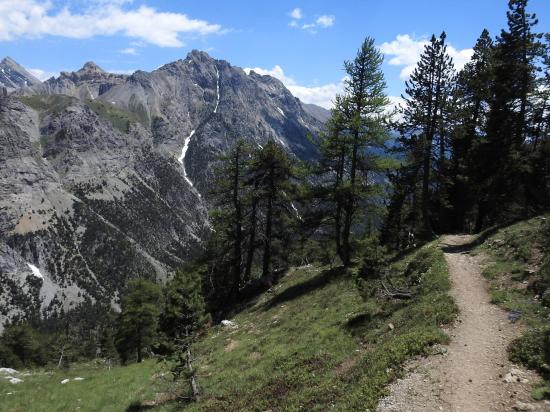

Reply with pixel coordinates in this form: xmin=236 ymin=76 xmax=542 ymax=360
xmin=315 ymin=38 xmax=389 ymax=266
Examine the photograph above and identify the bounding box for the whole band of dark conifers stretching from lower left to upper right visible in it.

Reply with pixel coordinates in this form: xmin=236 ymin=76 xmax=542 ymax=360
xmin=0 ymin=0 xmax=550 ymax=402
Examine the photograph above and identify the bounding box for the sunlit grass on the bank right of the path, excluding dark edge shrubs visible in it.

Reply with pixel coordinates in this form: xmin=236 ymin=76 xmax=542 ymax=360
xmin=473 ymin=216 xmax=550 ymax=399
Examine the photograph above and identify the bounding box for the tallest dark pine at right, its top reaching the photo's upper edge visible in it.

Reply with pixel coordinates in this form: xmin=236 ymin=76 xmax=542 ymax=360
xmin=486 ymin=0 xmax=542 ymax=225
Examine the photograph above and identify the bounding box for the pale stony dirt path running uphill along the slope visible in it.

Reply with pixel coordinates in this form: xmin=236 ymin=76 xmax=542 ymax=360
xmin=378 ymin=236 xmax=549 ymax=412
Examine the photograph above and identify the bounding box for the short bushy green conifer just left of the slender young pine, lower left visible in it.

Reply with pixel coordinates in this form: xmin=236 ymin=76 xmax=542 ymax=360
xmin=117 ymin=279 xmax=161 ymax=362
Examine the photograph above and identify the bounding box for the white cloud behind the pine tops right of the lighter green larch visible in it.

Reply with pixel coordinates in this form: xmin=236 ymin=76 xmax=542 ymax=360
xmin=380 ymin=34 xmax=473 ymax=80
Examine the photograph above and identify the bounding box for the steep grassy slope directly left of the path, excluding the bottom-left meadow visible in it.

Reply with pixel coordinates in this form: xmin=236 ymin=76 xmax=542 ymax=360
xmin=176 ymin=245 xmax=456 ymax=411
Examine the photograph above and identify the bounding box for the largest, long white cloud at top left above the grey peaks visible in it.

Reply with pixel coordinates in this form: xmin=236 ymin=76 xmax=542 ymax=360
xmin=0 ymin=0 xmax=223 ymax=47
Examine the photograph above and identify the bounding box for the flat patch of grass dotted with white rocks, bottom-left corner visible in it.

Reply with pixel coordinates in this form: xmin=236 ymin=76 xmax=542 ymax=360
xmin=0 ymin=360 xmax=168 ymax=412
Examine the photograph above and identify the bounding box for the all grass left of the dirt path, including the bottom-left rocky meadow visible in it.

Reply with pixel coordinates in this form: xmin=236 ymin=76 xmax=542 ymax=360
xmin=0 ymin=240 xmax=456 ymax=411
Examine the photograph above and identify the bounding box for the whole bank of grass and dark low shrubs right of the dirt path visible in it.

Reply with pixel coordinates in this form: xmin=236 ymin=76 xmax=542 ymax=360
xmin=475 ymin=216 xmax=550 ymax=399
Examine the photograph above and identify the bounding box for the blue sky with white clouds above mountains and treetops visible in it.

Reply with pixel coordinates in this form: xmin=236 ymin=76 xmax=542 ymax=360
xmin=0 ymin=0 xmax=550 ymax=106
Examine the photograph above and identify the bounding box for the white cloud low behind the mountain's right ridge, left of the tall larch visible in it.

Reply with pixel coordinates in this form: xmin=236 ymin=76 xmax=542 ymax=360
xmin=244 ymin=65 xmax=344 ymax=109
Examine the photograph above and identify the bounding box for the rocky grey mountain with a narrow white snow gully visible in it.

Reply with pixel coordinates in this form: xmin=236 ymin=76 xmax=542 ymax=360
xmin=0 ymin=51 xmax=323 ymax=330
